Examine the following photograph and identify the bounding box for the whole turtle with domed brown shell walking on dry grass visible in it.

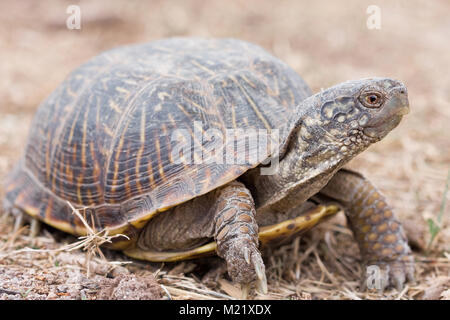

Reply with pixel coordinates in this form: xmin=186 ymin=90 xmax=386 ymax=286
xmin=3 ymin=37 xmax=414 ymax=292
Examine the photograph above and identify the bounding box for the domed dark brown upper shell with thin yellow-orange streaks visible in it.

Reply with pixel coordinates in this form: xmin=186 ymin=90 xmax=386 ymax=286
xmin=6 ymin=38 xmax=311 ymax=249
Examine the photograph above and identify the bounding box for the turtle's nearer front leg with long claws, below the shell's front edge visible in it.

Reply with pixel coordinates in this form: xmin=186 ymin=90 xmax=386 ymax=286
xmin=214 ymin=182 xmax=267 ymax=293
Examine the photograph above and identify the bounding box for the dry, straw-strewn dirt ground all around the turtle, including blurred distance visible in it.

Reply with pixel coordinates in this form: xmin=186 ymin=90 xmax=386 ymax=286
xmin=0 ymin=0 xmax=450 ymax=299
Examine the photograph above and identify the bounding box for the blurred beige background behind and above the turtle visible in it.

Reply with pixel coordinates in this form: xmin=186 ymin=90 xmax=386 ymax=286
xmin=0 ymin=0 xmax=450 ymax=300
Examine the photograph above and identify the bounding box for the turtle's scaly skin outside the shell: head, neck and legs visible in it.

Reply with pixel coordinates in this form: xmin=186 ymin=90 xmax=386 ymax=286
xmin=139 ymin=78 xmax=413 ymax=288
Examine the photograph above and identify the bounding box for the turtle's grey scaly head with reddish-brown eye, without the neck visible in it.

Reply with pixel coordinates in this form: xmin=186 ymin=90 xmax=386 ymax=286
xmin=314 ymin=78 xmax=409 ymax=151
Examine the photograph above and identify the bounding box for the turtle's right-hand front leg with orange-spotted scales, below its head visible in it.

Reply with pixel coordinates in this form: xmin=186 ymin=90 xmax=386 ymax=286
xmin=320 ymin=169 xmax=414 ymax=290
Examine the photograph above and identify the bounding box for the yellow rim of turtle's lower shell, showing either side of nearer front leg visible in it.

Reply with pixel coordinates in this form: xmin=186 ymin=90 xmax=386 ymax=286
xmin=124 ymin=205 xmax=339 ymax=262
